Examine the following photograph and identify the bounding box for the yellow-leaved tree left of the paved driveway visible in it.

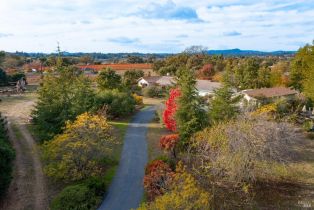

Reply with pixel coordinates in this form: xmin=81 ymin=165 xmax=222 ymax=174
xmin=43 ymin=113 xmax=115 ymax=181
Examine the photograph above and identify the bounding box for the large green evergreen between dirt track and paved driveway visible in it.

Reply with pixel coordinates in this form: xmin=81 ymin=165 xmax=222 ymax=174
xmin=32 ymin=66 xmax=94 ymax=140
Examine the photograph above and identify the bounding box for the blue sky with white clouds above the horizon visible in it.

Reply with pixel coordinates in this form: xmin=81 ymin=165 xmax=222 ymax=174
xmin=0 ymin=0 xmax=314 ymax=53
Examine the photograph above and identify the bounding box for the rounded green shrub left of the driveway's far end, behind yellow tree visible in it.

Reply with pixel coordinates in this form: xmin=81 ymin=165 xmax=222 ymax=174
xmin=93 ymin=90 xmax=136 ymax=118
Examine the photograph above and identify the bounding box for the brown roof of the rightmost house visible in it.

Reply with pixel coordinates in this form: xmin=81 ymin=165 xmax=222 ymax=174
xmin=243 ymin=87 xmax=298 ymax=98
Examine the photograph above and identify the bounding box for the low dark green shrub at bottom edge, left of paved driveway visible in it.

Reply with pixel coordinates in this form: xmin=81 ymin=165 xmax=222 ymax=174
xmin=51 ymin=184 xmax=102 ymax=210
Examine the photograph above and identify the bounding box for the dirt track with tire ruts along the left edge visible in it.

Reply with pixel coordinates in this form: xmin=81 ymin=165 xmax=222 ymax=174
xmin=0 ymin=95 xmax=48 ymax=210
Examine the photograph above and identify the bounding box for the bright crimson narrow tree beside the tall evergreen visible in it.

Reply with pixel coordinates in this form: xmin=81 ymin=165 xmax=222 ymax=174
xmin=163 ymin=88 xmax=181 ymax=131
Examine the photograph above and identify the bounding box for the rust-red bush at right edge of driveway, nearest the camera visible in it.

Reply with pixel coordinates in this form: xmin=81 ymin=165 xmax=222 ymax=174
xmin=144 ymin=160 xmax=174 ymax=201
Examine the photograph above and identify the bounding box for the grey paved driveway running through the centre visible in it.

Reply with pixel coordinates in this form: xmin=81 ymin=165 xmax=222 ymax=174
xmin=99 ymin=107 xmax=155 ymax=210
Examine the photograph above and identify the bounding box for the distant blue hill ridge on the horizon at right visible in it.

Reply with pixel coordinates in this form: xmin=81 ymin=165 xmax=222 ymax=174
xmin=208 ymin=49 xmax=296 ymax=56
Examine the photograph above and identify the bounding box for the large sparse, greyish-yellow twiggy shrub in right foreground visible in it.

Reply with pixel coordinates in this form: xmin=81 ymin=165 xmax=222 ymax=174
xmin=192 ymin=118 xmax=301 ymax=185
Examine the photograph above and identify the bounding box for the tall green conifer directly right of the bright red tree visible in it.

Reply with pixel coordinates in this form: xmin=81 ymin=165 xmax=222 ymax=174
xmin=175 ymin=68 xmax=208 ymax=146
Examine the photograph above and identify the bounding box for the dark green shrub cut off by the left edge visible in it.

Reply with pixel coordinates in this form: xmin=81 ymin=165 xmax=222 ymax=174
xmin=0 ymin=116 xmax=15 ymax=197
